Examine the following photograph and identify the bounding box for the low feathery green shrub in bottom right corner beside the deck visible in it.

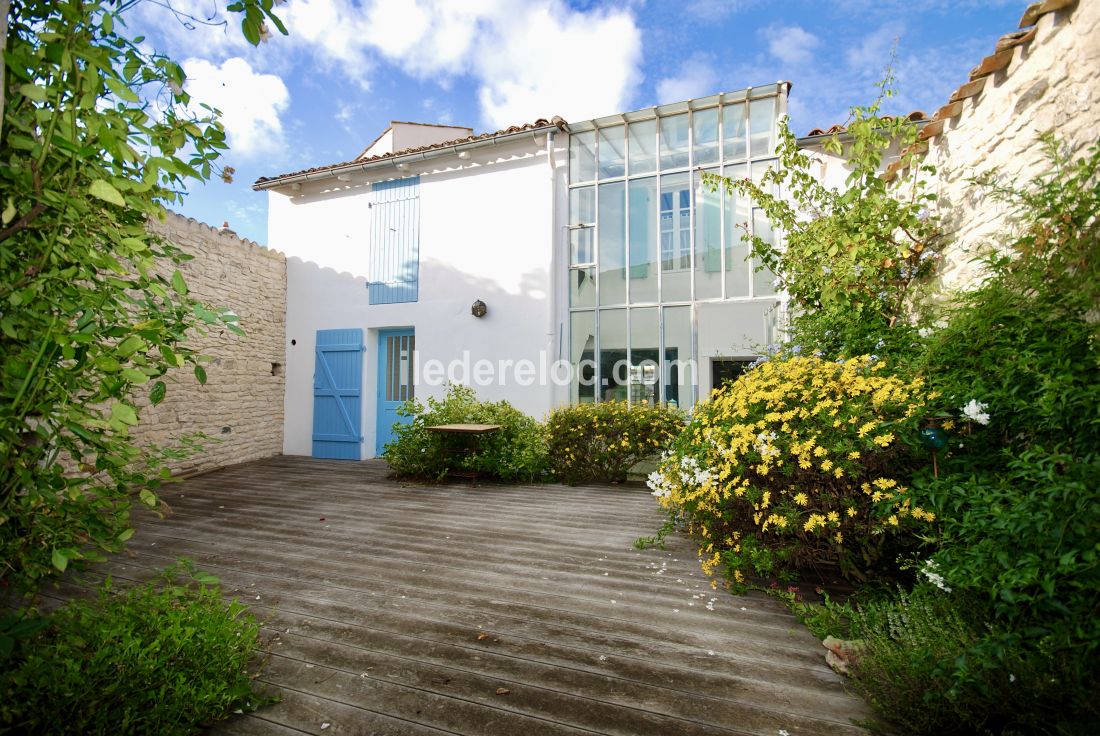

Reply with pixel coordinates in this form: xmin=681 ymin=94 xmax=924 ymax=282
xmin=850 ymin=584 xmax=1100 ymax=736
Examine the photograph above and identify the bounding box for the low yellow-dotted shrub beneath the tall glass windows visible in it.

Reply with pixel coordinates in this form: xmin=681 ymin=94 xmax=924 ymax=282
xmin=547 ymin=402 xmax=684 ymax=485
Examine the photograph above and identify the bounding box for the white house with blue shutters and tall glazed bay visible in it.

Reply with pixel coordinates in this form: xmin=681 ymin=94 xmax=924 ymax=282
xmin=254 ymin=83 xmax=789 ymax=459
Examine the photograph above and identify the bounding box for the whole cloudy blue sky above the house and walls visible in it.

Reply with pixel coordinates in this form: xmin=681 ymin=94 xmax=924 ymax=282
xmin=128 ymin=0 xmax=1026 ymax=243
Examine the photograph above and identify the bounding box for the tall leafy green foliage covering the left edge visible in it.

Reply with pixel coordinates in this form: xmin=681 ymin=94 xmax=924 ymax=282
xmin=0 ymin=0 xmax=283 ymax=590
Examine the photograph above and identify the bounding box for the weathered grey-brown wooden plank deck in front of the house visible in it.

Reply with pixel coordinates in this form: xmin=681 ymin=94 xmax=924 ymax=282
xmin=45 ymin=458 xmax=868 ymax=736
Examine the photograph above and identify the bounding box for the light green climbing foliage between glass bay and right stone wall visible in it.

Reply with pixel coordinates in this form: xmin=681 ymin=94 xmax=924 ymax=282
xmin=704 ymin=75 xmax=941 ymax=356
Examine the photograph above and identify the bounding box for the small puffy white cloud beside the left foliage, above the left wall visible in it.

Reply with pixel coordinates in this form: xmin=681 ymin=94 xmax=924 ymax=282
xmin=183 ymin=56 xmax=290 ymax=157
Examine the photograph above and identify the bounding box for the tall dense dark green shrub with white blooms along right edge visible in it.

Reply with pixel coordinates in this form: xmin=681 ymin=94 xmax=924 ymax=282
xmin=875 ymin=142 xmax=1100 ymax=733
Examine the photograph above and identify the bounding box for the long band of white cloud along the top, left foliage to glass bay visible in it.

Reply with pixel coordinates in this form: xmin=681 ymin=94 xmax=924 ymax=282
xmin=142 ymin=0 xmax=642 ymax=128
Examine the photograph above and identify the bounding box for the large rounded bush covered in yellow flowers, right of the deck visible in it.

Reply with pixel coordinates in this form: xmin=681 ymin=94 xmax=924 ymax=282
xmin=649 ymin=355 xmax=934 ymax=586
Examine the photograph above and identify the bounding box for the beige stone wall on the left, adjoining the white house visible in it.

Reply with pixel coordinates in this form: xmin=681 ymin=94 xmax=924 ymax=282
xmin=133 ymin=212 xmax=286 ymax=475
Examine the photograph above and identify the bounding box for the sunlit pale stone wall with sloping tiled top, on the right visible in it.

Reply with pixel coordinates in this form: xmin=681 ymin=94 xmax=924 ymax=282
xmin=887 ymin=0 xmax=1100 ymax=290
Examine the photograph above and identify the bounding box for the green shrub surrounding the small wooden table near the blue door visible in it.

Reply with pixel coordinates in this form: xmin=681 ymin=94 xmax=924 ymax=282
xmin=384 ymin=384 xmax=547 ymax=481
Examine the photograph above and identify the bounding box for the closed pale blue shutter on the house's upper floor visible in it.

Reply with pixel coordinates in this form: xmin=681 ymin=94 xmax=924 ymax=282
xmin=366 ymin=176 xmax=420 ymax=304
